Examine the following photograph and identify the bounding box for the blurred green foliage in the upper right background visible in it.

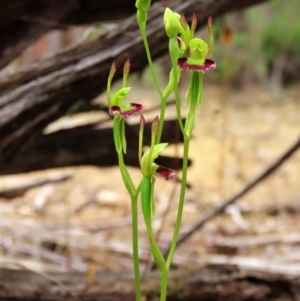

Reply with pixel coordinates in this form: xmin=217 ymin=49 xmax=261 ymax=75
xmin=209 ymin=0 xmax=300 ymax=87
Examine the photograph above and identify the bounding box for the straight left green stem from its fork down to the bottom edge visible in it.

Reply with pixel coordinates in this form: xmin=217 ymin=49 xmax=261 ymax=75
xmin=131 ymin=194 xmax=141 ymax=301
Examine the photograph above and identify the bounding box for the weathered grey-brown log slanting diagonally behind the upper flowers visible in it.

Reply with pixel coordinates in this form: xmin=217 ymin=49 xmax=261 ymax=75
xmin=0 ymin=0 xmax=265 ymax=172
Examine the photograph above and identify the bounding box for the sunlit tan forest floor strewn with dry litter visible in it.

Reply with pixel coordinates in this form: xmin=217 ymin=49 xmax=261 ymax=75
xmin=0 ymin=86 xmax=300 ymax=290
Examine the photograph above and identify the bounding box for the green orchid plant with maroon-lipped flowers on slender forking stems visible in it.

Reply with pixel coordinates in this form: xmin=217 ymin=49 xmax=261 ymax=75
xmin=107 ymin=0 xmax=216 ymax=301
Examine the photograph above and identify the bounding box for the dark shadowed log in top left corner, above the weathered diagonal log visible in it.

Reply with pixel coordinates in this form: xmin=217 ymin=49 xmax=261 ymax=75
xmin=0 ymin=0 xmax=162 ymax=69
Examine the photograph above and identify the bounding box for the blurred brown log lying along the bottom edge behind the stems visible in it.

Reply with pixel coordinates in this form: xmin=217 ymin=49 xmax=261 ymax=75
xmin=0 ymin=265 xmax=300 ymax=301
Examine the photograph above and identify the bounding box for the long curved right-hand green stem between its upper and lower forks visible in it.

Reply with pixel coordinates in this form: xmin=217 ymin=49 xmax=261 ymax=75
xmin=166 ymin=136 xmax=190 ymax=269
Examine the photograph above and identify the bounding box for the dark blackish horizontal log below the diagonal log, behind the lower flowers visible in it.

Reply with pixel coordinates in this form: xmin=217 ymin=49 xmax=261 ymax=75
xmin=0 ymin=120 xmax=183 ymax=174
